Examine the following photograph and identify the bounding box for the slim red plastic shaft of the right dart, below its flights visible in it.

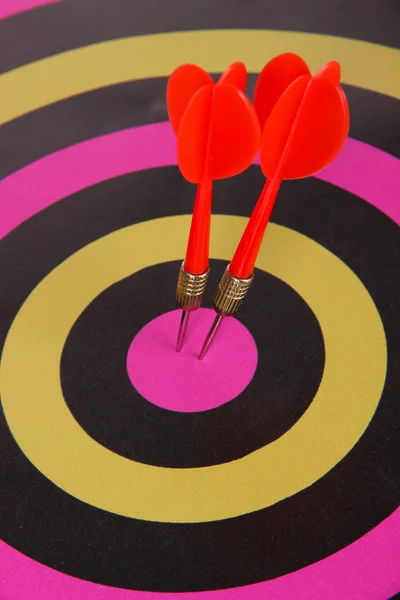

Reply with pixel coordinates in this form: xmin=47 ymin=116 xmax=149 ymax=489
xmin=229 ymin=177 xmax=281 ymax=279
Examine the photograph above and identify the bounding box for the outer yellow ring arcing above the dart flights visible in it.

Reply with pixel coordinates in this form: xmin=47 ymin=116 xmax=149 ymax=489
xmin=0 ymin=30 xmax=400 ymax=124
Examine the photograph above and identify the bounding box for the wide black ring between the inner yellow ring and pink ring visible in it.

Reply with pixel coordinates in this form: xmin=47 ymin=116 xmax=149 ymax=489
xmin=0 ymin=168 xmax=400 ymax=592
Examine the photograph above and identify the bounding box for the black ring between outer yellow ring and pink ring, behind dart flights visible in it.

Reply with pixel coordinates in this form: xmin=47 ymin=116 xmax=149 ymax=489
xmin=0 ymin=75 xmax=400 ymax=177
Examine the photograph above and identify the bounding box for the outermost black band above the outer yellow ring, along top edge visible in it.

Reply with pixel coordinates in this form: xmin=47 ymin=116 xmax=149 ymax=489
xmin=0 ymin=0 xmax=399 ymax=72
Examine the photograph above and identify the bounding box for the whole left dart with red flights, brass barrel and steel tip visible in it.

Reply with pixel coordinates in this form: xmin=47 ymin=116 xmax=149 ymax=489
xmin=167 ymin=63 xmax=261 ymax=351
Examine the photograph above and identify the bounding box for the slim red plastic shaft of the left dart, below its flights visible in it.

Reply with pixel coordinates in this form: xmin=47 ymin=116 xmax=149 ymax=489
xmin=184 ymin=179 xmax=212 ymax=275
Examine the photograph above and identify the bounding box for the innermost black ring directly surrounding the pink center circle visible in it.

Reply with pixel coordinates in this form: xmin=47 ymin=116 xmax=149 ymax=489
xmin=61 ymin=258 xmax=325 ymax=468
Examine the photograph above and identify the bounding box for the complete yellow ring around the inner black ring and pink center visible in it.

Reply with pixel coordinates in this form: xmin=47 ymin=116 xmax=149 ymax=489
xmin=1 ymin=215 xmax=386 ymax=522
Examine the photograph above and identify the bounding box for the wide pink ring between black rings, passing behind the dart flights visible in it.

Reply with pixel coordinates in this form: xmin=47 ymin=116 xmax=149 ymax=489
xmin=0 ymin=123 xmax=400 ymax=600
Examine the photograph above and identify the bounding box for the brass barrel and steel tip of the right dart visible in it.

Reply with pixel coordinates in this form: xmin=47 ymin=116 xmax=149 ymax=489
xmin=199 ymin=265 xmax=254 ymax=360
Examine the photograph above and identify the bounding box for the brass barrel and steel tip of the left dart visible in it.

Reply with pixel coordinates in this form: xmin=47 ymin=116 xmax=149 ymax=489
xmin=176 ymin=262 xmax=210 ymax=352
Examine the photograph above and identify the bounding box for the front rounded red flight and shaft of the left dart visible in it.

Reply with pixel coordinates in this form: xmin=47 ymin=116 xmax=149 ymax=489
xmin=177 ymin=84 xmax=260 ymax=275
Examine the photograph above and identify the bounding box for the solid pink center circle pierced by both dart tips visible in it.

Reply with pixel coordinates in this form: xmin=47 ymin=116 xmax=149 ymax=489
xmin=127 ymin=308 xmax=258 ymax=412
